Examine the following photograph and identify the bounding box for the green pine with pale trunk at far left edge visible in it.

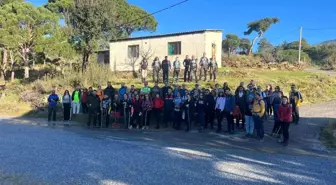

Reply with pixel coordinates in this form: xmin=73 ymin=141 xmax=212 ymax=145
xmin=0 ymin=1 xmax=58 ymax=78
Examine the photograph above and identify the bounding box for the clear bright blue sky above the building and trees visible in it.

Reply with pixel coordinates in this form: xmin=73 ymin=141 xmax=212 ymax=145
xmin=29 ymin=0 xmax=336 ymax=45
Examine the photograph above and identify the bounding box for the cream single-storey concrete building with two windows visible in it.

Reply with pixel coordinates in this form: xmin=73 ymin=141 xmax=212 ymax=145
xmin=109 ymin=30 xmax=222 ymax=71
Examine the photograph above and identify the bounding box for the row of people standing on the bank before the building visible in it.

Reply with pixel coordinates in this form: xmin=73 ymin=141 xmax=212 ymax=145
xmin=140 ymin=53 xmax=218 ymax=82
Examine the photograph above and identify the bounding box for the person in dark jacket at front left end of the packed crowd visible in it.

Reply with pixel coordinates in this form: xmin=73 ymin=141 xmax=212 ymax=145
xmin=87 ymin=91 xmax=101 ymax=127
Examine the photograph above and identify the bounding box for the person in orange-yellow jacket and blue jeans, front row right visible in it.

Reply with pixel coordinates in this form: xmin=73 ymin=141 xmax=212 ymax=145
xmin=252 ymin=93 xmax=265 ymax=142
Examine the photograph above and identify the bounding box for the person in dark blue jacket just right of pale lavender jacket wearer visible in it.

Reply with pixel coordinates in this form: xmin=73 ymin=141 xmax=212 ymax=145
xmin=224 ymin=90 xmax=236 ymax=134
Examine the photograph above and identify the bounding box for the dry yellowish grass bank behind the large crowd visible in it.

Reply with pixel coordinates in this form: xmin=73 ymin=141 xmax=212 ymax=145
xmin=0 ymin=64 xmax=336 ymax=116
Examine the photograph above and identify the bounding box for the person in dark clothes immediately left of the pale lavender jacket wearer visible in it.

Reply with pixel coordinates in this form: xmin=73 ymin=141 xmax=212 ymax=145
xmin=204 ymin=90 xmax=216 ymax=129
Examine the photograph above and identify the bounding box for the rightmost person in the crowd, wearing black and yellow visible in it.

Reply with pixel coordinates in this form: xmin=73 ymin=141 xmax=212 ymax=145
xmin=289 ymin=84 xmax=303 ymax=124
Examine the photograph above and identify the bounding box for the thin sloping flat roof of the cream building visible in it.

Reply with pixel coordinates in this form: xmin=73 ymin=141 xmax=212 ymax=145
xmin=110 ymin=29 xmax=222 ymax=42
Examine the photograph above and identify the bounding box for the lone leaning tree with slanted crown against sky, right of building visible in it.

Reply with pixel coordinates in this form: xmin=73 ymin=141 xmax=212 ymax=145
xmin=244 ymin=17 xmax=279 ymax=54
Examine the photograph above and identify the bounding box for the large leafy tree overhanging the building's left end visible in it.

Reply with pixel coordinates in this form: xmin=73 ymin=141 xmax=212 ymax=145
xmin=65 ymin=0 xmax=157 ymax=71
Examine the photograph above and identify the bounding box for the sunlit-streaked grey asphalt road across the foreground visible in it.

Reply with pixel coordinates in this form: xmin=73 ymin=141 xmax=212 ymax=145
xmin=0 ymin=119 xmax=336 ymax=185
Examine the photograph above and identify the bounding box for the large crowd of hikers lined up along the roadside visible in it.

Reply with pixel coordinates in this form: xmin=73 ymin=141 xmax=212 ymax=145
xmin=48 ymin=80 xmax=302 ymax=145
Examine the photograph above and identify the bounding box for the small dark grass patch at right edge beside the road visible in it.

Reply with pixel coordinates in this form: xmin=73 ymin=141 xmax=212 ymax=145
xmin=321 ymin=120 xmax=336 ymax=148
